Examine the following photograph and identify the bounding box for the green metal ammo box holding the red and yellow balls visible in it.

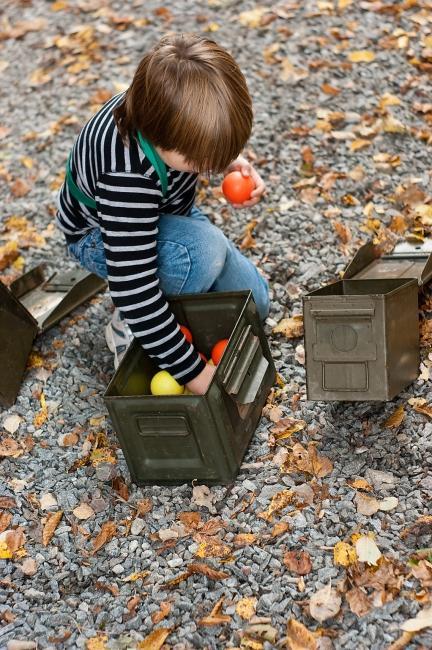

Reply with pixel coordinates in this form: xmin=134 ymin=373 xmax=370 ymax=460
xmin=104 ymin=291 xmax=276 ymax=485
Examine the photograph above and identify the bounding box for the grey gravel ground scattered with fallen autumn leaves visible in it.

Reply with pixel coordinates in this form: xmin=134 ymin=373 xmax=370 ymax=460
xmin=0 ymin=0 xmax=432 ymax=650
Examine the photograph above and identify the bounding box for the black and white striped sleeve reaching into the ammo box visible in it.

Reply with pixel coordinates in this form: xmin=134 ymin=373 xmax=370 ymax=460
xmin=95 ymin=172 xmax=204 ymax=384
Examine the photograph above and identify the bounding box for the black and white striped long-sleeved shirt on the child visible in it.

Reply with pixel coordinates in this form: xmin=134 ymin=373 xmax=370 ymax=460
xmin=56 ymin=93 xmax=204 ymax=384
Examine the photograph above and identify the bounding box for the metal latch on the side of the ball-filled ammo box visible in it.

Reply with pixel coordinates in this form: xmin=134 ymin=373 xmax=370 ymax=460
xmin=222 ymin=325 xmax=269 ymax=404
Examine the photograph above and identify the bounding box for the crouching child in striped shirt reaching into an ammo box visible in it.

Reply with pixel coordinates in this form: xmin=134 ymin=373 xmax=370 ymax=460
xmin=57 ymin=34 xmax=269 ymax=395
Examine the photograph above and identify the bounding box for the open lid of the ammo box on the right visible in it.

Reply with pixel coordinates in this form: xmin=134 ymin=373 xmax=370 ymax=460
xmin=343 ymin=239 xmax=432 ymax=287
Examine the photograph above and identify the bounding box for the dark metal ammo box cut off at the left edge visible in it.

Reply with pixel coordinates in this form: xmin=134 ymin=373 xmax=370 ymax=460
xmin=0 ymin=264 xmax=106 ymax=407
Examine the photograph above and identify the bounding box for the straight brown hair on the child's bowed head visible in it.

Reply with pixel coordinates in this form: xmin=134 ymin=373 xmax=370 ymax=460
xmin=114 ymin=34 xmax=252 ymax=172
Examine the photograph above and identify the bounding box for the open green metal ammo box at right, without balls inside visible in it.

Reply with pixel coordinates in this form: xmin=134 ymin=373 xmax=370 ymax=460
xmin=303 ymin=241 xmax=432 ymax=401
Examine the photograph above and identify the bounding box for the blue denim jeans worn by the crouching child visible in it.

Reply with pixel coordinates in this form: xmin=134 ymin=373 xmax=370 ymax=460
xmin=68 ymin=207 xmax=269 ymax=320
